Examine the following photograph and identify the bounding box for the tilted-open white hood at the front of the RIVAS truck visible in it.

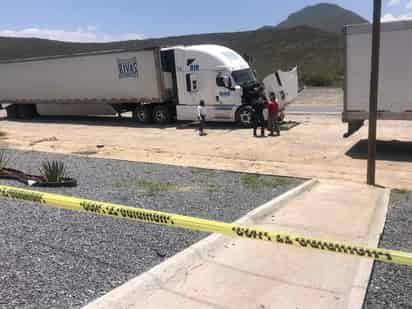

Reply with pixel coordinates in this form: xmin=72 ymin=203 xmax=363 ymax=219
xmin=263 ymin=67 xmax=299 ymax=110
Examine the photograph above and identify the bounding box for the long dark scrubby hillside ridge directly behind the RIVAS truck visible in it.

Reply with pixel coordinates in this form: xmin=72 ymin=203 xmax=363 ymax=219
xmin=0 ymin=27 xmax=343 ymax=83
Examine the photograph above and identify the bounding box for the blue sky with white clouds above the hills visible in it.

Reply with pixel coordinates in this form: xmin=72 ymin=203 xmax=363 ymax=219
xmin=0 ymin=0 xmax=412 ymax=42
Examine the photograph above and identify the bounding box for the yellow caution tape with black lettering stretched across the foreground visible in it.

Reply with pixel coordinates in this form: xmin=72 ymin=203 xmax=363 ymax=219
xmin=0 ymin=186 xmax=412 ymax=266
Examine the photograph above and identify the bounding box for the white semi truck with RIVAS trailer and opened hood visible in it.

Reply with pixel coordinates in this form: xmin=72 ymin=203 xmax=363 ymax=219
xmin=0 ymin=45 xmax=298 ymax=126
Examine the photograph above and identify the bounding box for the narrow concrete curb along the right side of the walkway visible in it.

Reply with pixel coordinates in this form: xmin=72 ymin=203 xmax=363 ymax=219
xmin=346 ymin=189 xmax=391 ymax=309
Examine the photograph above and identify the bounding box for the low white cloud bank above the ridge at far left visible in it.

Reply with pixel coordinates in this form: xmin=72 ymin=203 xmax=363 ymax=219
xmin=0 ymin=26 xmax=144 ymax=42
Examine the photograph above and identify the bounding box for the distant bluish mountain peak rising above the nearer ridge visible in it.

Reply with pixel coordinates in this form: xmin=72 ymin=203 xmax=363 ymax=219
xmin=277 ymin=3 xmax=368 ymax=32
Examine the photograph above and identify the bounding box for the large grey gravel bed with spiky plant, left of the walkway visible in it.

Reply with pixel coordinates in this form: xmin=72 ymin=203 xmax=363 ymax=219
xmin=0 ymin=151 xmax=302 ymax=308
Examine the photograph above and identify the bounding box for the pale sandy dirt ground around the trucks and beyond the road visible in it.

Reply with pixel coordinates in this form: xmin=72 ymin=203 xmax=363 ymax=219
xmin=0 ymin=89 xmax=412 ymax=189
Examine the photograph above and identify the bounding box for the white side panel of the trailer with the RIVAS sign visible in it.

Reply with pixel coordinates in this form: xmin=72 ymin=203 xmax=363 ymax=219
xmin=0 ymin=50 xmax=164 ymax=104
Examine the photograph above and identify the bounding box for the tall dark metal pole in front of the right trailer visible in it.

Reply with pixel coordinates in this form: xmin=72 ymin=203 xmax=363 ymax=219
xmin=367 ymin=0 xmax=382 ymax=185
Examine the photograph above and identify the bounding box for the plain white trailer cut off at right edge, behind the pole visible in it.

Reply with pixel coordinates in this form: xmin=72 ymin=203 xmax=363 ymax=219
xmin=342 ymin=21 xmax=412 ymax=137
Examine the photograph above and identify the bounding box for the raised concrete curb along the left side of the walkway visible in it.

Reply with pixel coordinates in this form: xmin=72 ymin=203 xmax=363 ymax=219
xmin=83 ymin=179 xmax=318 ymax=309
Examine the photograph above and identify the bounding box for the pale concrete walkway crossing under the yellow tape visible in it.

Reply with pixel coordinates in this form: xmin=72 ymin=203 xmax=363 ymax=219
xmin=87 ymin=181 xmax=389 ymax=309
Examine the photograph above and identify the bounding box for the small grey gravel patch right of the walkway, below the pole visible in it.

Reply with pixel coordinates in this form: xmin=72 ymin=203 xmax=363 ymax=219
xmin=364 ymin=191 xmax=412 ymax=309
